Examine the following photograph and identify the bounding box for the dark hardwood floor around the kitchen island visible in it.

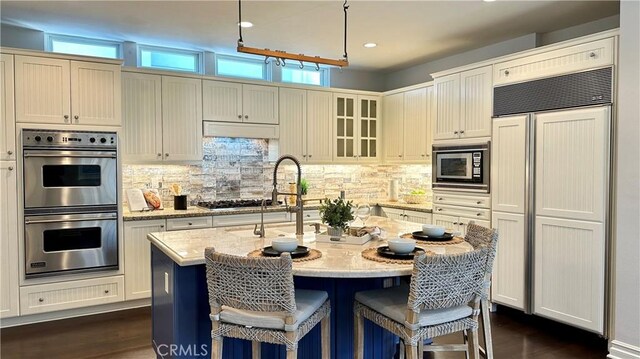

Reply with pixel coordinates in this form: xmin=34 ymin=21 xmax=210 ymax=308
xmin=0 ymin=307 xmax=607 ymax=359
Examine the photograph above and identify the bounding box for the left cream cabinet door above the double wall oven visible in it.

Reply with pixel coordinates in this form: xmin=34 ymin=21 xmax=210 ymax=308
xmin=15 ymin=56 xmax=71 ymax=124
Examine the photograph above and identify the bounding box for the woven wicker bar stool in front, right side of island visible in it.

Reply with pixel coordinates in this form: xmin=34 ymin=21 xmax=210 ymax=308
xmin=354 ymin=228 xmax=497 ymax=359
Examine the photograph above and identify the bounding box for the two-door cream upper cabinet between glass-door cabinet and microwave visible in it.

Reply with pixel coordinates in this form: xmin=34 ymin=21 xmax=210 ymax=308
xmin=382 ymin=86 xmax=433 ymax=162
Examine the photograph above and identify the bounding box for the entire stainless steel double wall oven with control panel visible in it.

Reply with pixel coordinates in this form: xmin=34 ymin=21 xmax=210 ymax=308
xmin=22 ymin=129 xmax=118 ymax=277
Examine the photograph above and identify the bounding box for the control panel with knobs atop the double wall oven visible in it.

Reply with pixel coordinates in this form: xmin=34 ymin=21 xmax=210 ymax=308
xmin=22 ymin=129 xmax=118 ymax=149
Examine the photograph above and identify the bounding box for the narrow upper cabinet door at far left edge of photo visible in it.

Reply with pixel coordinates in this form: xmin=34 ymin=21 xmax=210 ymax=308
xmin=0 ymin=54 xmax=16 ymax=161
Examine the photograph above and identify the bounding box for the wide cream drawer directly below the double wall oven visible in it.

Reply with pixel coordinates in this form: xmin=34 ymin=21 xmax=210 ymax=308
xmin=20 ymin=276 xmax=124 ymax=315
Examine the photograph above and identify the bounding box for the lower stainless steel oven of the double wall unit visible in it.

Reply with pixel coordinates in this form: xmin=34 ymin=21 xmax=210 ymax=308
xmin=24 ymin=212 xmax=118 ymax=275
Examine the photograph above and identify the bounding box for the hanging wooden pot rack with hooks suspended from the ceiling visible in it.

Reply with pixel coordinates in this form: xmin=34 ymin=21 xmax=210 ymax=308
xmin=237 ymin=0 xmax=349 ymax=71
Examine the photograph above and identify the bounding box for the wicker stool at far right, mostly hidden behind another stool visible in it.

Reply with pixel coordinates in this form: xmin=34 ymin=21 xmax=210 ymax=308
xmin=464 ymin=221 xmax=498 ymax=359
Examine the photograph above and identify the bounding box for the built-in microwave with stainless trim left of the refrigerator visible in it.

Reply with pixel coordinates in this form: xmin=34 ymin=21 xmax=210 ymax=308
xmin=432 ymin=141 xmax=491 ymax=193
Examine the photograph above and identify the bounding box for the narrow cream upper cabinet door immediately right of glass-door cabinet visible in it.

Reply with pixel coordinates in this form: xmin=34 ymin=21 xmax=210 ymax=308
xmin=382 ymin=93 xmax=405 ymax=161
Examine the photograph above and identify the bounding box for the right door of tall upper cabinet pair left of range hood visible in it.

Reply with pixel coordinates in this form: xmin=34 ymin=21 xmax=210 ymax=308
xmin=162 ymin=76 xmax=202 ymax=161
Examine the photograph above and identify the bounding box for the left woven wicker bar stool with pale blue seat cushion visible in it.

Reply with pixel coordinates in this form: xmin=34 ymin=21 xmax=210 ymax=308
xmin=205 ymin=248 xmax=331 ymax=359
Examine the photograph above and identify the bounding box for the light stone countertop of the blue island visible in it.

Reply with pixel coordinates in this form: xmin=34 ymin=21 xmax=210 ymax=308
xmin=147 ymin=216 xmax=471 ymax=278
